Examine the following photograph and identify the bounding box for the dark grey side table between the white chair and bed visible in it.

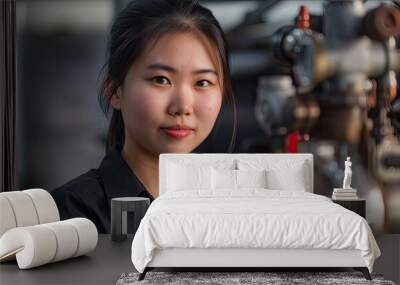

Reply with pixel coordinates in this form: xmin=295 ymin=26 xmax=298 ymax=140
xmin=111 ymin=197 xmax=150 ymax=241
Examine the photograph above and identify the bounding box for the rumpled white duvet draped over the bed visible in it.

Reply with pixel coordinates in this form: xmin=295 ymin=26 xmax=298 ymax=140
xmin=132 ymin=188 xmax=380 ymax=272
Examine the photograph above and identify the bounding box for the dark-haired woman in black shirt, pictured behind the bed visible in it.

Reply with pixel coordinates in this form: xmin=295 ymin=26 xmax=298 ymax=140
xmin=51 ymin=0 xmax=236 ymax=233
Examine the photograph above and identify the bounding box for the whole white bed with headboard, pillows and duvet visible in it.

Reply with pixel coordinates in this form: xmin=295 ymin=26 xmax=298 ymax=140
xmin=132 ymin=154 xmax=380 ymax=279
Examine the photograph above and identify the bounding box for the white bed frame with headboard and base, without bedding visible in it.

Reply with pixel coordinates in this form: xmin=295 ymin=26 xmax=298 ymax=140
xmin=139 ymin=153 xmax=371 ymax=280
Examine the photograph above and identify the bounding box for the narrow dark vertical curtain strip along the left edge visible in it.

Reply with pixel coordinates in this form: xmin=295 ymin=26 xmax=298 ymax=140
xmin=0 ymin=0 xmax=16 ymax=192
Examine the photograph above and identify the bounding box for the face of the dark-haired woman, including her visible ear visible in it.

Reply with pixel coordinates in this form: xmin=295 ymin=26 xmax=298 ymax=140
xmin=111 ymin=33 xmax=222 ymax=156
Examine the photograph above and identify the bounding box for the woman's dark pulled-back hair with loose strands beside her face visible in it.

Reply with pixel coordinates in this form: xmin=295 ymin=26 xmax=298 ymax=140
xmin=99 ymin=0 xmax=237 ymax=152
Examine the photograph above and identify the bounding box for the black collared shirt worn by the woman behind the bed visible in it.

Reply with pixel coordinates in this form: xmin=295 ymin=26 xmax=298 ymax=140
xmin=50 ymin=146 xmax=154 ymax=233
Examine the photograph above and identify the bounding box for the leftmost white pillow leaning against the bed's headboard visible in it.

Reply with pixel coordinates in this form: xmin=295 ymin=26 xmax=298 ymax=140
xmin=167 ymin=163 xmax=211 ymax=191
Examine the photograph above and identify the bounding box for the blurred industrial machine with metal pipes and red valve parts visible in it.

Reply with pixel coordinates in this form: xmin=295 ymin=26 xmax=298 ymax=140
xmin=230 ymin=0 xmax=400 ymax=233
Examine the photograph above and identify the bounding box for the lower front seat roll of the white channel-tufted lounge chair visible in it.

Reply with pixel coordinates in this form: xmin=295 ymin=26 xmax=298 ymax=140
xmin=0 ymin=218 xmax=98 ymax=269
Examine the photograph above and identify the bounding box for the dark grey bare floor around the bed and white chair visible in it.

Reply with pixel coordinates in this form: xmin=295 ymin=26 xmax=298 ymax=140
xmin=0 ymin=235 xmax=400 ymax=285
